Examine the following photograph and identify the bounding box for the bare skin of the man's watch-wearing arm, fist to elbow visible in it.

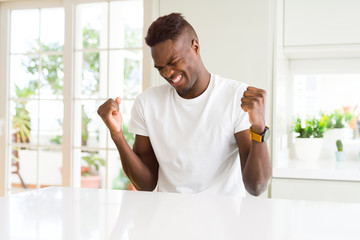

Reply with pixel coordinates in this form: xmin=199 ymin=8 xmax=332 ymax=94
xmin=235 ymin=87 xmax=271 ymax=196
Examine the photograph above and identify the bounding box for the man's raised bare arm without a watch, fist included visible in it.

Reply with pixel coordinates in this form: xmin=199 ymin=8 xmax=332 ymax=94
xmin=98 ymin=97 xmax=159 ymax=191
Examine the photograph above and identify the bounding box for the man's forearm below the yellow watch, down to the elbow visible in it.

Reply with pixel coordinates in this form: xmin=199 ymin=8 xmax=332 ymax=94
xmin=243 ymin=140 xmax=271 ymax=196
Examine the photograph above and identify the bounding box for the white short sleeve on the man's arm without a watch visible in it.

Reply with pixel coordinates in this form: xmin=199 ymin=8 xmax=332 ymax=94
xmin=129 ymin=95 xmax=149 ymax=136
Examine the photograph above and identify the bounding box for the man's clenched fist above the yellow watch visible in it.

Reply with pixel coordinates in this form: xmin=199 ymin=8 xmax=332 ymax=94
xmin=241 ymin=87 xmax=266 ymax=133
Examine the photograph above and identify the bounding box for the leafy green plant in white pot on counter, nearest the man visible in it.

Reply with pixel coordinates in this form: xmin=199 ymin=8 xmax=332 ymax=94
xmin=292 ymin=117 xmax=325 ymax=161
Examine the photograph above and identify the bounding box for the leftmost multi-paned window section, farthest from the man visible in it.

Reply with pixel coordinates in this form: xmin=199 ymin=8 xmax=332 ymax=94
xmin=8 ymin=8 xmax=64 ymax=191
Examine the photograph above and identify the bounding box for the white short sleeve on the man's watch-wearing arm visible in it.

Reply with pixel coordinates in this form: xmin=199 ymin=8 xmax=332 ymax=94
xmin=234 ymin=84 xmax=251 ymax=133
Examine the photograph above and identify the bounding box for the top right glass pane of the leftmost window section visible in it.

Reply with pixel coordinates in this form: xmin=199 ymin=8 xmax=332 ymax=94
xmin=40 ymin=8 xmax=65 ymax=51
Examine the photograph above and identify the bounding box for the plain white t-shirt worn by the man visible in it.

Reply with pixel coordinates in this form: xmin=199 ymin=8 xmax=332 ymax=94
xmin=129 ymin=75 xmax=250 ymax=196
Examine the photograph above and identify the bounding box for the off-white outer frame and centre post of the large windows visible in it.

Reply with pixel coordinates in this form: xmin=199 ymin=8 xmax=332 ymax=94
xmin=0 ymin=0 xmax=161 ymax=196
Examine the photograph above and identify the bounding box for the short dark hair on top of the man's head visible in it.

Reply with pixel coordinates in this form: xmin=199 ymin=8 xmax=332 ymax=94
xmin=145 ymin=13 xmax=198 ymax=47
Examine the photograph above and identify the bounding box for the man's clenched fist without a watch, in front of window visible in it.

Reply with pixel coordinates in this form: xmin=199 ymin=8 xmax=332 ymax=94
xmin=97 ymin=97 xmax=122 ymax=134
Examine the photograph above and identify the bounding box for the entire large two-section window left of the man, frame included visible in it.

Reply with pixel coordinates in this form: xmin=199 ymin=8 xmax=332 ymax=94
xmin=0 ymin=0 xmax=145 ymax=195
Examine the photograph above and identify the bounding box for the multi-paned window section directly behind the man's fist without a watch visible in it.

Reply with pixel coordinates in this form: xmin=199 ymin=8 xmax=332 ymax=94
xmin=74 ymin=1 xmax=143 ymax=188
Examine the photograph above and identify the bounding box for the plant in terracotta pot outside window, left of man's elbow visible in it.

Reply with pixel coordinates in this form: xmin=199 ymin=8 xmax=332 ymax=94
xmin=81 ymin=152 xmax=105 ymax=188
